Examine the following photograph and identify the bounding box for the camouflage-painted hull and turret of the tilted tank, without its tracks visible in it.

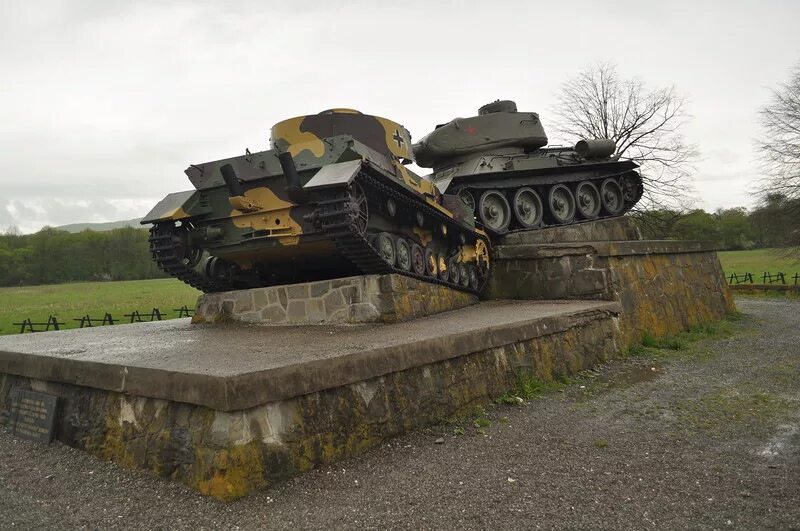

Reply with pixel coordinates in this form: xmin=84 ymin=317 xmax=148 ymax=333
xmin=143 ymin=109 xmax=488 ymax=294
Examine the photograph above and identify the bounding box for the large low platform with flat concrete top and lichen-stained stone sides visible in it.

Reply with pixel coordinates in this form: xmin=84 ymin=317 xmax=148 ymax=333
xmin=0 ymin=301 xmax=620 ymax=499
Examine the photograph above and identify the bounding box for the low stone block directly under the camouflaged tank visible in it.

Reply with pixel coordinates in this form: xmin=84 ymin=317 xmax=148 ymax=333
xmin=192 ymin=275 xmax=478 ymax=325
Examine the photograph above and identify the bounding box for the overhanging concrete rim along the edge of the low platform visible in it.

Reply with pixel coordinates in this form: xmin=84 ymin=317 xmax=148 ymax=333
xmin=0 ymin=302 xmax=621 ymax=411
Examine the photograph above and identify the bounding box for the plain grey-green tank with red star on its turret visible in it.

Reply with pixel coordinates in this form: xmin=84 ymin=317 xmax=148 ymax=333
xmin=413 ymin=100 xmax=643 ymax=234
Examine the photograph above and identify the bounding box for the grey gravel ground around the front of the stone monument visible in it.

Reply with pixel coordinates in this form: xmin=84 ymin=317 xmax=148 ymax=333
xmin=0 ymin=298 xmax=800 ymax=529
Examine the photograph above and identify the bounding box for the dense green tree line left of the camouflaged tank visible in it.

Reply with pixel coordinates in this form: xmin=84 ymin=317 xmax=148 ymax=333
xmin=0 ymin=227 xmax=165 ymax=286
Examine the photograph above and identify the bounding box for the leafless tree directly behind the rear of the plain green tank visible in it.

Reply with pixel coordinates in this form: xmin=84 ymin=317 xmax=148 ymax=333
xmin=554 ymin=63 xmax=697 ymax=208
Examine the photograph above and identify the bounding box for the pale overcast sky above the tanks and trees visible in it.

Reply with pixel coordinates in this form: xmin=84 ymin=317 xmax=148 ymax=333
xmin=0 ymin=0 xmax=800 ymax=232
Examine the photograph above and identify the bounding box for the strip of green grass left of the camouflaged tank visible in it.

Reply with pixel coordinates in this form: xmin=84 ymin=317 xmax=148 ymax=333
xmin=0 ymin=278 xmax=200 ymax=334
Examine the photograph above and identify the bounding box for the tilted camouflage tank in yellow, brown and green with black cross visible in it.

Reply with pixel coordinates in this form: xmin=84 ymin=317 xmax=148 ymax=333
xmin=142 ymin=109 xmax=489 ymax=292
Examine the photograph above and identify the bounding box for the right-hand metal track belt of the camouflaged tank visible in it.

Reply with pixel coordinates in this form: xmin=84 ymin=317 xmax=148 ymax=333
xmin=319 ymin=171 xmax=489 ymax=294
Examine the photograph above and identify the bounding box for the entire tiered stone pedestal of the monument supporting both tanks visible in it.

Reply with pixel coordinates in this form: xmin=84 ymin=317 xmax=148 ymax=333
xmin=0 ymin=214 xmax=733 ymax=500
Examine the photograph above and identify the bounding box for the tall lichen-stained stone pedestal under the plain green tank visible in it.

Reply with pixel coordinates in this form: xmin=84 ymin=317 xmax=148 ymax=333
xmin=483 ymin=217 xmax=735 ymax=343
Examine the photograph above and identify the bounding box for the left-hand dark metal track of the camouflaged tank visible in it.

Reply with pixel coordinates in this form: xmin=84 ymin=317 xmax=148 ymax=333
xmin=147 ymin=222 xmax=234 ymax=293
